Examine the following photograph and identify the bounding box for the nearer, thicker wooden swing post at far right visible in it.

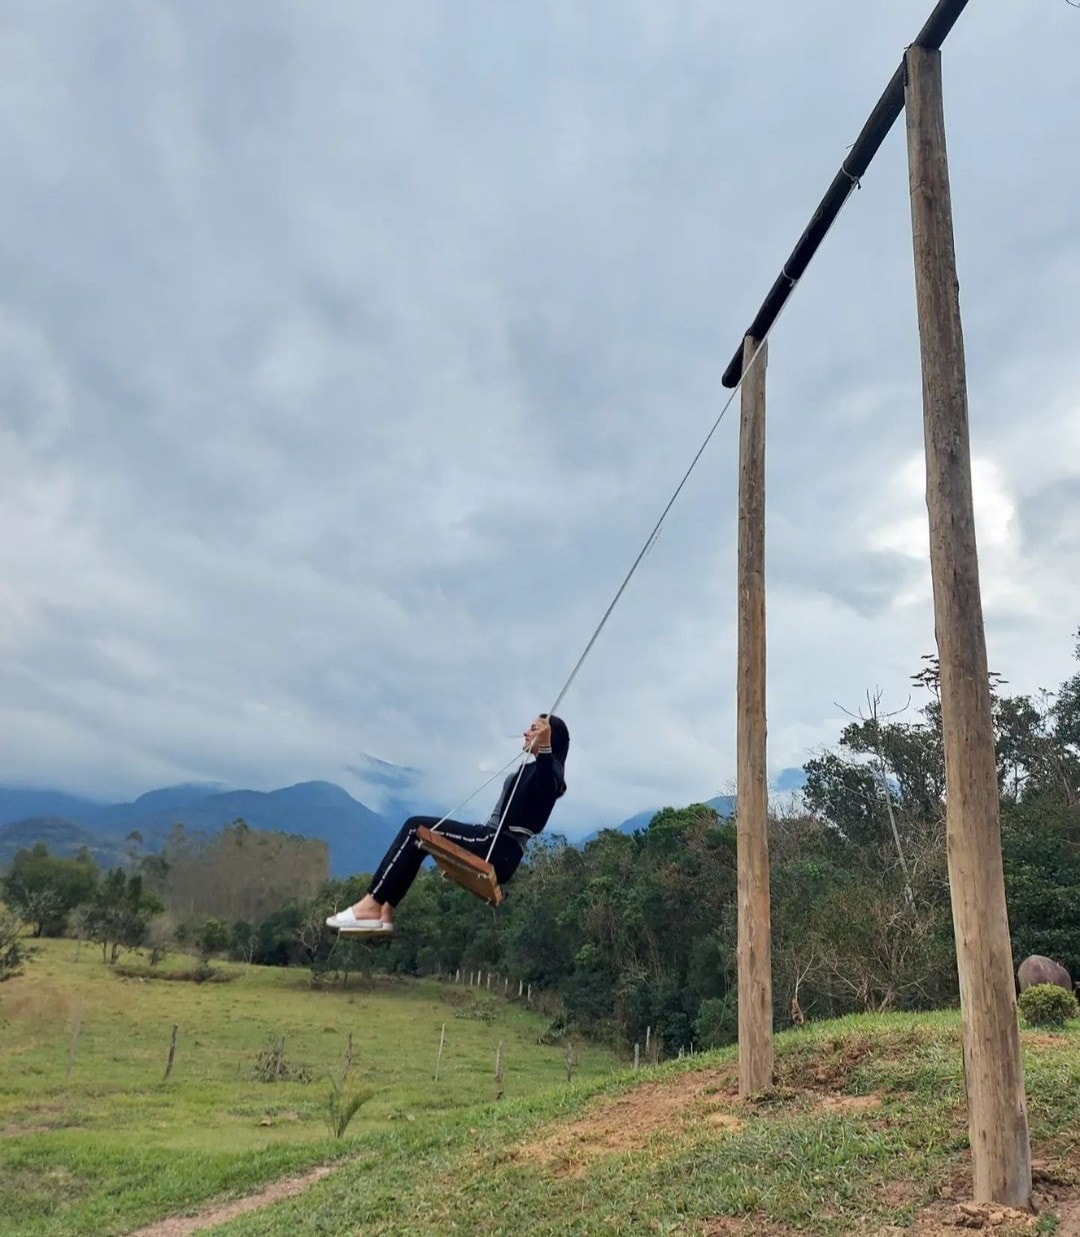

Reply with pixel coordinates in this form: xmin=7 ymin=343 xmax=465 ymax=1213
xmin=906 ymin=47 xmax=1032 ymax=1207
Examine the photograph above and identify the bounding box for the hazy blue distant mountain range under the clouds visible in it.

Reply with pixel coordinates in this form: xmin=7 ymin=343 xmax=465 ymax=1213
xmin=0 ymin=782 xmax=752 ymax=877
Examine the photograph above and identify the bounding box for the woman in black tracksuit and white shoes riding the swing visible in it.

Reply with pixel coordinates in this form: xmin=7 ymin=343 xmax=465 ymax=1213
xmin=327 ymin=713 xmax=570 ymax=933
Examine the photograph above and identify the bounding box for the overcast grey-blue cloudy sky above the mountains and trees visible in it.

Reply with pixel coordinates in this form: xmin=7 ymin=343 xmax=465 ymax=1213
xmin=0 ymin=0 xmax=1080 ymax=836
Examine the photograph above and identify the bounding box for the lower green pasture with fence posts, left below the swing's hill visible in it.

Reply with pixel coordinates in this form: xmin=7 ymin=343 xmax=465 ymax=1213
xmin=0 ymin=941 xmax=617 ymax=1237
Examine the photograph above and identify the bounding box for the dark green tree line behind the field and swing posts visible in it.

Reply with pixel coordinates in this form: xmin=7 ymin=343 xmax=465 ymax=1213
xmin=4 ymin=633 xmax=1080 ymax=1051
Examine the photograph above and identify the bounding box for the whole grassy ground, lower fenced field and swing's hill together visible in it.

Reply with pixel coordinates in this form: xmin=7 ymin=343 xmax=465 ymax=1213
xmin=0 ymin=941 xmax=1080 ymax=1237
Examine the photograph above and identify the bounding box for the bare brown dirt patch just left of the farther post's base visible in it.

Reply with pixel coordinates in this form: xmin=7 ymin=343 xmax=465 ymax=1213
xmin=516 ymin=1069 xmax=742 ymax=1175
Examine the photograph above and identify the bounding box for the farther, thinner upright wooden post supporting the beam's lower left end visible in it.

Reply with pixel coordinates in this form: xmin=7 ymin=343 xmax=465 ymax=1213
xmin=735 ymin=335 xmax=773 ymax=1096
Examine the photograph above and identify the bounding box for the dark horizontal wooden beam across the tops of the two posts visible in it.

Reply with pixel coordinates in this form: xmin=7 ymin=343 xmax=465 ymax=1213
xmin=724 ymin=0 xmax=967 ymax=387
